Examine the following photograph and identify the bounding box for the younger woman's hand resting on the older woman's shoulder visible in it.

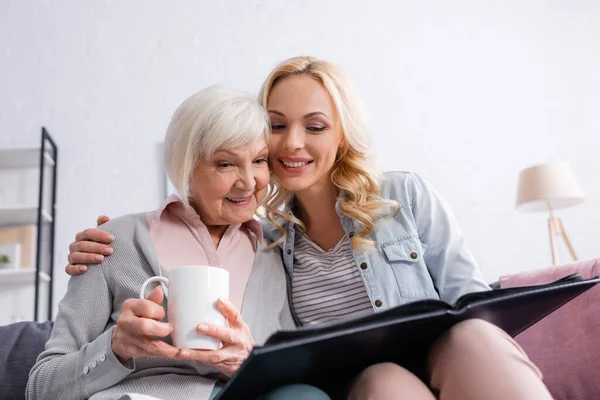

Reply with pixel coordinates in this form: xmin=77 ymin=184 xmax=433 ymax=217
xmin=65 ymin=215 xmax=114 ymax=275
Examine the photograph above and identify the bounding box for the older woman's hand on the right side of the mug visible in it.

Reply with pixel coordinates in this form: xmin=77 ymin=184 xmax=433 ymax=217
xmin=179 ymin=299 xmax=254 ymax=378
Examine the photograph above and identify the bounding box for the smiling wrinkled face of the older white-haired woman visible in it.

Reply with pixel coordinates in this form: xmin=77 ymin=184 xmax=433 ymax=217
xmin=189 ymin=138 xmax=270 ymax=226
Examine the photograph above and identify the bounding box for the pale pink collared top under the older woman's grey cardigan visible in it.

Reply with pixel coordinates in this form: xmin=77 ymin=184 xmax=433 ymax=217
xmin=147 ymin=195 xmax=263 ymax=310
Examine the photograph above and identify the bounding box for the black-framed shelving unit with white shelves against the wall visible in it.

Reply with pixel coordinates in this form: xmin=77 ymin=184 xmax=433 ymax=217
xmin=0 ymin=127 xmax=58 ymax=325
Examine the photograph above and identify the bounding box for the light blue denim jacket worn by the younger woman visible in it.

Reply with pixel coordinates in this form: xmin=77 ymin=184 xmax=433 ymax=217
xmin=263 ymin=172 xmax=489 ymax=324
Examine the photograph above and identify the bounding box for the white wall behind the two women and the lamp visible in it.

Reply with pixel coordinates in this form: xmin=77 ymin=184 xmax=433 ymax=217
xmin=0 ymin=0 xmax=600 ymax=312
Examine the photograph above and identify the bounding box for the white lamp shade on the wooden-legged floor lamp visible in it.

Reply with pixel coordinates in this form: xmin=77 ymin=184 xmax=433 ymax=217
xmin=517 ymin=163 xmax=585 ymax=212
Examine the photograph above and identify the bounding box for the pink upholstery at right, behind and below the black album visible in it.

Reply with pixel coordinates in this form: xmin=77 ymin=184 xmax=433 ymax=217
xmin=500 ymin=259 xmax=600 ymax=400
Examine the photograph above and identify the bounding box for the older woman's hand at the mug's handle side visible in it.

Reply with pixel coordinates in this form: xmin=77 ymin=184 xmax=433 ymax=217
xmin=111 ymin=286 xmax=179 ymax=363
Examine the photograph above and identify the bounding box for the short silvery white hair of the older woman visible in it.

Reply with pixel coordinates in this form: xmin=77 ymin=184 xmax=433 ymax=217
xmin=164 ymin=86 xmax=271 ymax=204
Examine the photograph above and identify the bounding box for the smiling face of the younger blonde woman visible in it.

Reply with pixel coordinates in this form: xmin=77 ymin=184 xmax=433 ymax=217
xmin=267 ymin=75 xmax=344 ymax=192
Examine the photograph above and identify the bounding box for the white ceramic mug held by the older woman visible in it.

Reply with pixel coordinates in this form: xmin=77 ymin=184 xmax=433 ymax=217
xmin=140 ymin=265 xmax=229 ymax=350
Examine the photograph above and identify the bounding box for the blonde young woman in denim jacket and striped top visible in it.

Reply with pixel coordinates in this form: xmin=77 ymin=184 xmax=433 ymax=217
xmin=67 ymin=57 xmax=551 ymax=400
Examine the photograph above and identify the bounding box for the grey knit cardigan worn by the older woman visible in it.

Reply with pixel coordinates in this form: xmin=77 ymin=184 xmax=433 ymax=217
xmin=26 ymin=213 xmax=294 ymax=400
